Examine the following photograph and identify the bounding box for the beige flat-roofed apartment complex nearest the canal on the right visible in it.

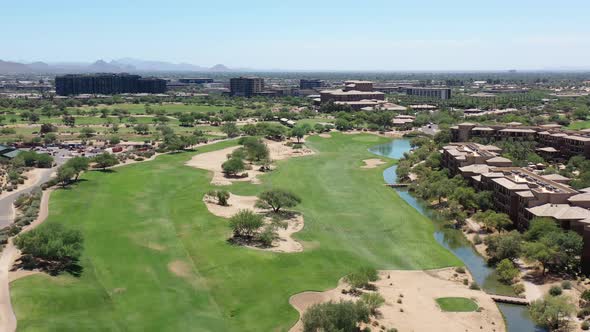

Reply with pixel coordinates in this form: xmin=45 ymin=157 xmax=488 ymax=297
xmin=441 ymin=143 xmax=590 ymax=273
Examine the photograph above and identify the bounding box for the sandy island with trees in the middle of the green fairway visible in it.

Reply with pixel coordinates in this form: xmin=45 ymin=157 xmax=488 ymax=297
xmin=203 ymin=194 xmax=305 ymax=252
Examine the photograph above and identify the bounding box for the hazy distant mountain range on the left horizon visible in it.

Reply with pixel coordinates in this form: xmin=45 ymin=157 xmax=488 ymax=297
xmin=0 ymin=58 xmax=240 ymax=74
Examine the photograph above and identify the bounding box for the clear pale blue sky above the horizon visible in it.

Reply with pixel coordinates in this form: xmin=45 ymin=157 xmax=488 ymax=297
xmin=0 ymin=0 xmax=590 ymax=70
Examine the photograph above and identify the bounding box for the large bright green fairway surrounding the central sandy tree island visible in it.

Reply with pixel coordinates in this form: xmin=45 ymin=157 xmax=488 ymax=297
xmin=11 ymin=134 xmax=462 ymax=331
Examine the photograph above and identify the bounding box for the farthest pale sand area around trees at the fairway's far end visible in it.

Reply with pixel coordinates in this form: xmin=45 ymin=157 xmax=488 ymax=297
xmin=186 ymin=140 xmax=313 ymax=186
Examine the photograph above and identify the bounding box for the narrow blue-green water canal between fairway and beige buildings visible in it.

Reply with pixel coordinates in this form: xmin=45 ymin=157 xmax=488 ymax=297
xmin=369 ymin=139 xmax=545 ymax=332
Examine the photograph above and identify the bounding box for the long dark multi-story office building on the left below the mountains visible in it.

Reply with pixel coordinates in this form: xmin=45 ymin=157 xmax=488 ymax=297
xmin=55 ymin=74 xmax=166 ymax=96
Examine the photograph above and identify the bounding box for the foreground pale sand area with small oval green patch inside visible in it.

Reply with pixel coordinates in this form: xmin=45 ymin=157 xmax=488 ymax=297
xmin=289 ymin=268 xmax=506 ymax=332
